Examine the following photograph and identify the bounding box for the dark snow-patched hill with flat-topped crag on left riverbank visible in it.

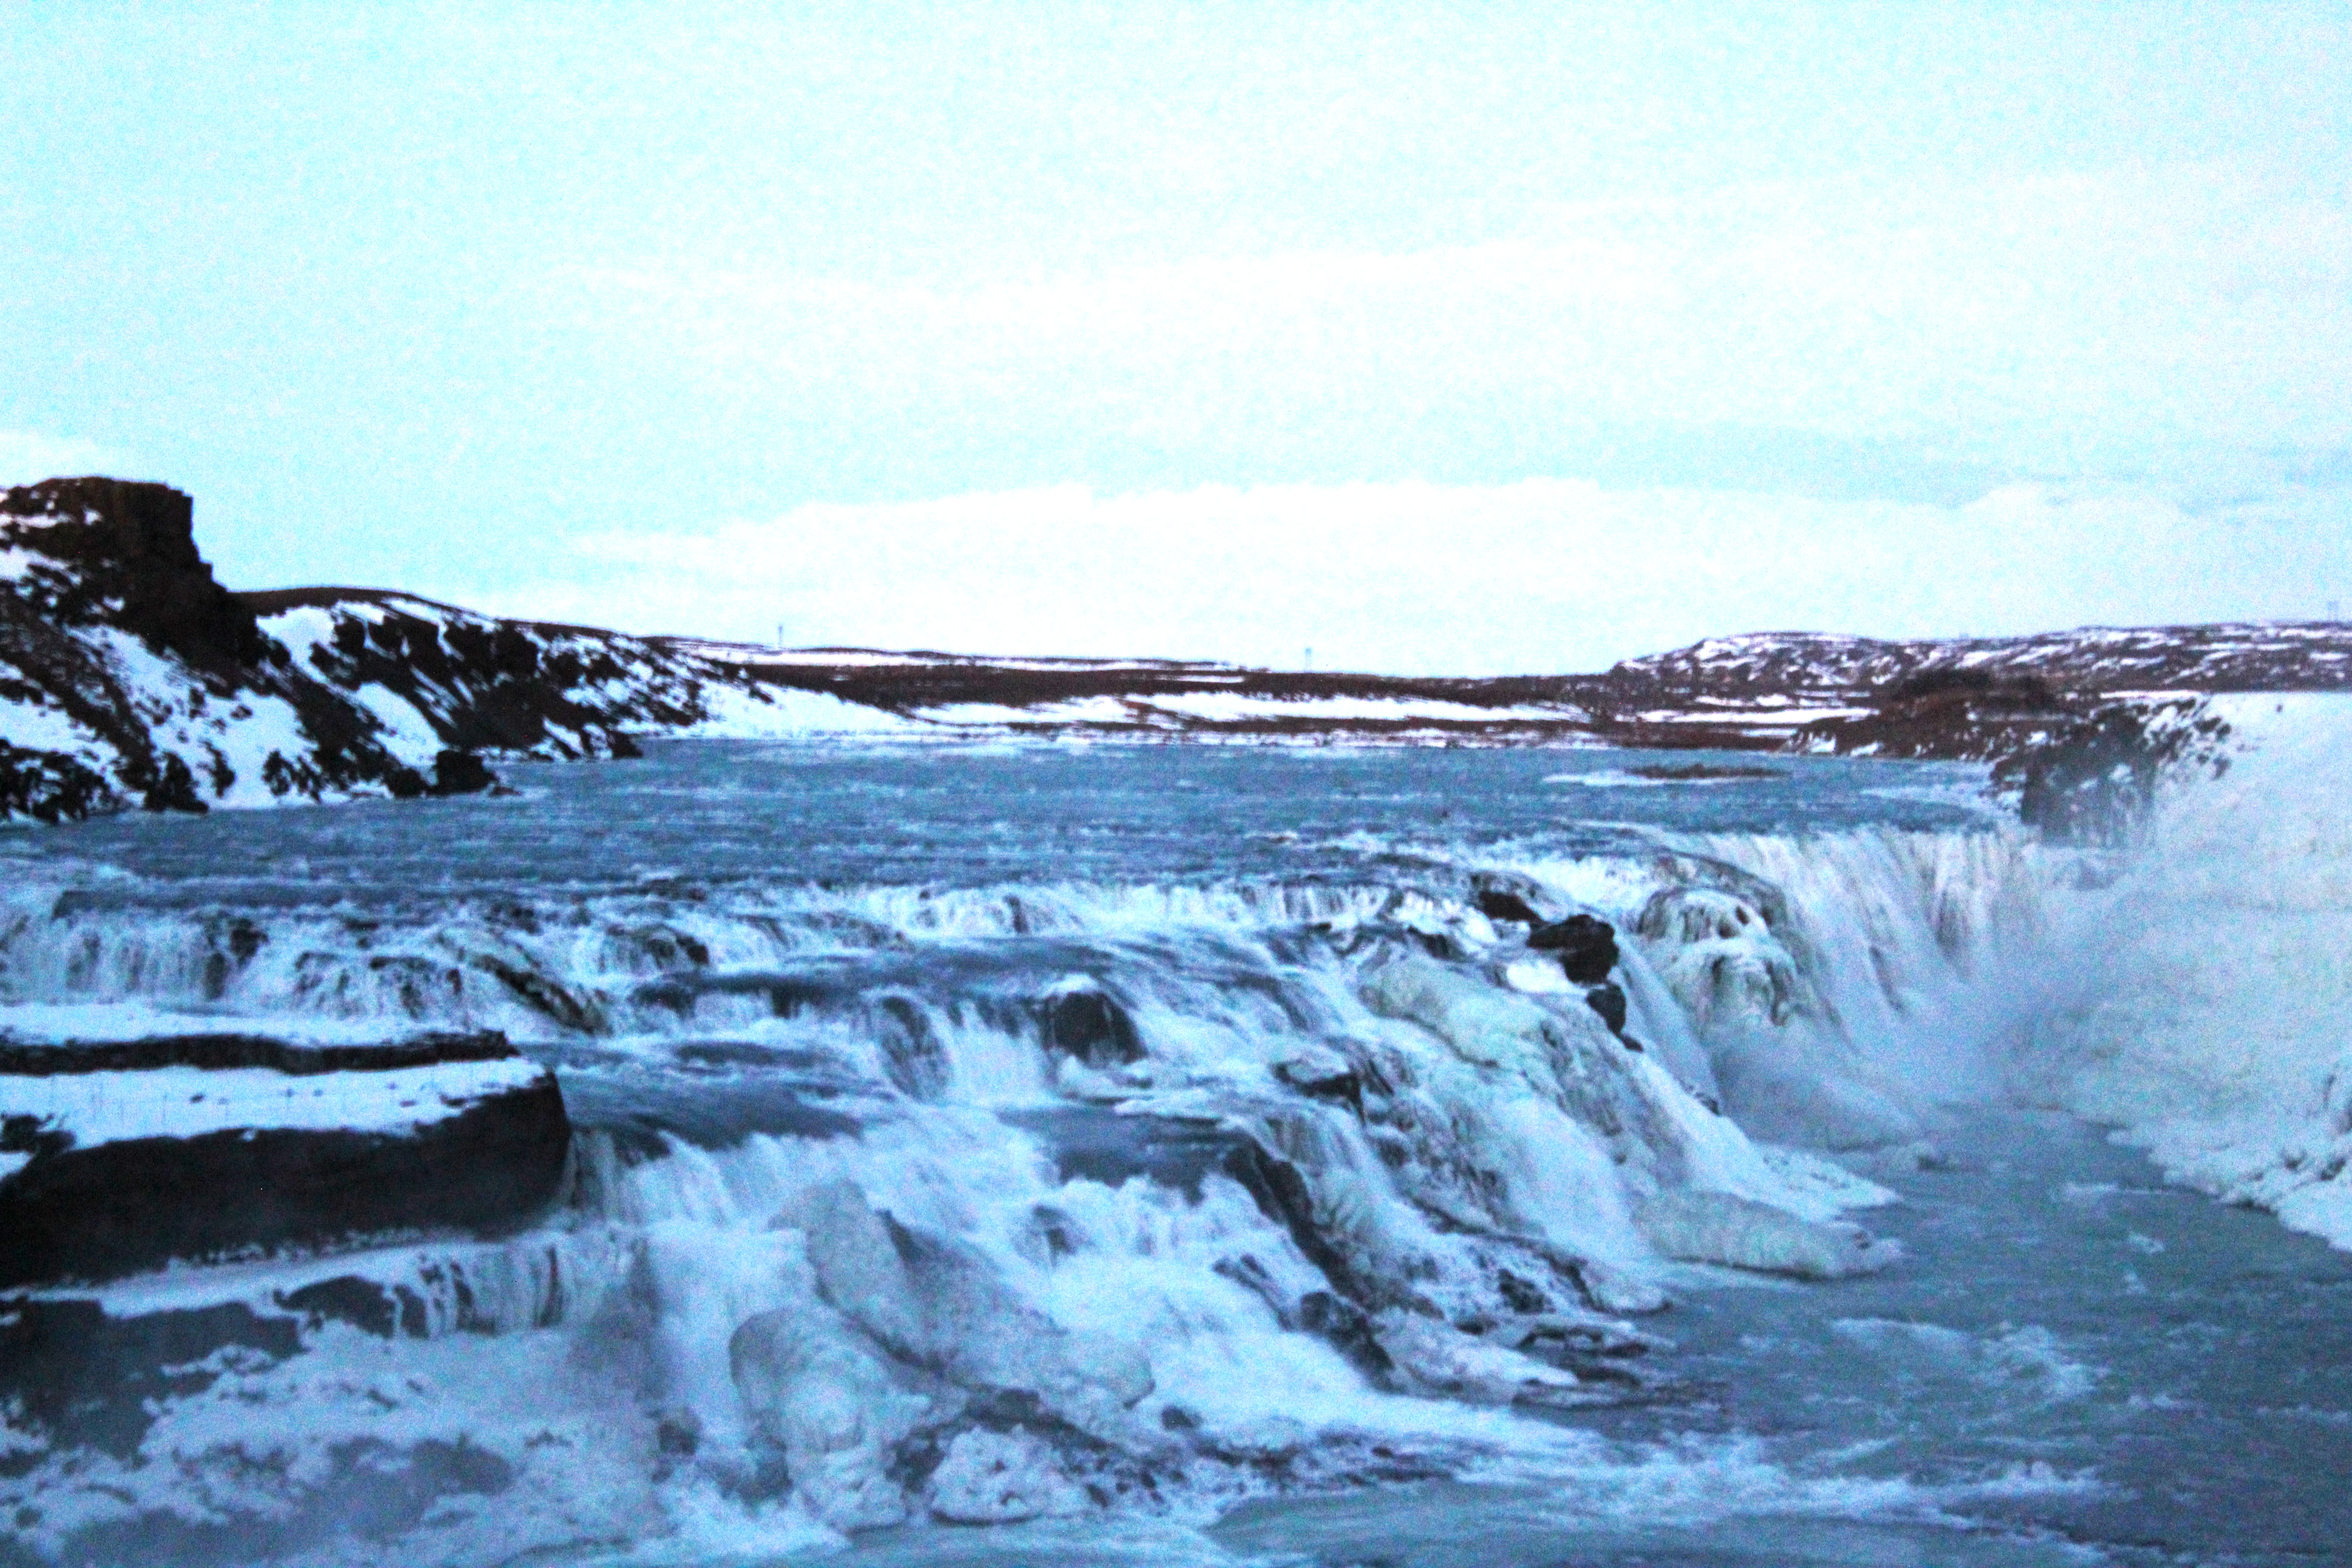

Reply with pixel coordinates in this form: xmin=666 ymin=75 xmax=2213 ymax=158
xmin=0 ymin=480 xmax=908 ymax=823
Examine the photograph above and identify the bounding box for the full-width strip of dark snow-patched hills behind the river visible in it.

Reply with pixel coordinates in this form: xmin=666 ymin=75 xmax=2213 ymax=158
xmin=0 ymin=477 xmax=2352 ymax=820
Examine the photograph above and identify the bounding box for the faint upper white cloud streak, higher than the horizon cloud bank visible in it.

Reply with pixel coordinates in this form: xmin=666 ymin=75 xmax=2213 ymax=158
xmin=574 ymin=165 xmax=2352 ymax=461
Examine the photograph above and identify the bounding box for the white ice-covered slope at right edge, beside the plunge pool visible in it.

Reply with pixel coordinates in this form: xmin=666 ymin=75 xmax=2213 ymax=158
xmin=2046 ymin=696 xmax=2352 ymax=1246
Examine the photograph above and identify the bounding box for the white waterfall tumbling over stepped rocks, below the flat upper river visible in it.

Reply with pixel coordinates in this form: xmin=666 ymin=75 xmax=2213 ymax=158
xmin=0 ymin=808 xmax=2072 ymax=1561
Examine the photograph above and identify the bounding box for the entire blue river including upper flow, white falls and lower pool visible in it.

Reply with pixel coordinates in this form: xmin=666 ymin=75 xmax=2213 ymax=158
xmin=0 ymin=743 xmax=2352 ymax=1568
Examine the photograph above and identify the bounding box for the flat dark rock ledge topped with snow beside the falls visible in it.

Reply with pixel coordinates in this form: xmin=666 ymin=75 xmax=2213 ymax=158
xmin=0 ymin=1034 xmax=572 ymax=1288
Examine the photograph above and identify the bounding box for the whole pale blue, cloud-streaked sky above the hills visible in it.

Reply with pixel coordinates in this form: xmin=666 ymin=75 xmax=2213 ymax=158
xmin=0 ymin=2 xmax=2352 ymax=670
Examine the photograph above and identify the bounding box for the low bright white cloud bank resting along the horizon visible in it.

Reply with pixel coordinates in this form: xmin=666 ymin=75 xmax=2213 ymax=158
xmin=472 ymin=480 xmax=2352 ymax=675
